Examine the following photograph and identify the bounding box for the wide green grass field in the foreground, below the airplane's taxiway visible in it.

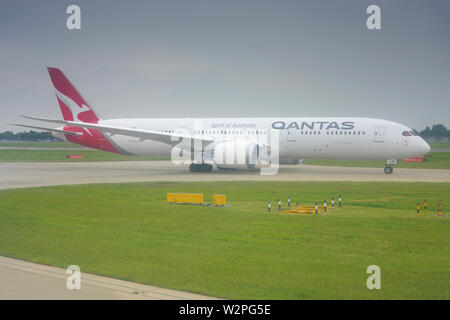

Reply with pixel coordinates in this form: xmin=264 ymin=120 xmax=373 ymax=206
xmin=0 ymin=182 xmax=450 ymax=299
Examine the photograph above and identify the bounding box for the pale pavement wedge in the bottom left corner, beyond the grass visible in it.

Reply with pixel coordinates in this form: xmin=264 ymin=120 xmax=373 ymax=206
xmin=0 ymin=256 xmax=213 ymax=300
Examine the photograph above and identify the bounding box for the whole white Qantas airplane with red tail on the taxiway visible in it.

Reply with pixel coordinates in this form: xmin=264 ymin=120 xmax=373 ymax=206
xmin=14 ymin=67 xmax=430 ymax=174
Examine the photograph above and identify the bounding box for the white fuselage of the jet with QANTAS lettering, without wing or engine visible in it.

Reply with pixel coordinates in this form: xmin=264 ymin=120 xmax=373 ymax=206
xmin=99 ymin=118 xmax=430 ymax=163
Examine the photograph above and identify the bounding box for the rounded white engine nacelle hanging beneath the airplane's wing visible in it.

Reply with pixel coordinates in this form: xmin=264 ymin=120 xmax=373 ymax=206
xmin=210 ymin=141 xmax=261 ymax=169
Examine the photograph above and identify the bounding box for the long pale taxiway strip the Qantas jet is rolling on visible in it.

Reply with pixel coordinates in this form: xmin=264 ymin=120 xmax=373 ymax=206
xmin=0 ymin=161 xmax=450 ymax=189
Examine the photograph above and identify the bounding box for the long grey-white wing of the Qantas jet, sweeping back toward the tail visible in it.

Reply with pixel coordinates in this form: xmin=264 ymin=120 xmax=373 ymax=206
xmin=23 ymin=116 xmax=214 ymax=146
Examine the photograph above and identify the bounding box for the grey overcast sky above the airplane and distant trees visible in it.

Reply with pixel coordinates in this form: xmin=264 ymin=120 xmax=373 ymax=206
xmin=0 ymin=0 xmax=450 ymax=131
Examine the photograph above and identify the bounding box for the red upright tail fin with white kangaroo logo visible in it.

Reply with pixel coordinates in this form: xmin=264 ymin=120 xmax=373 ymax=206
xmin=47 ymin=68 xmax=100 ymax=123
